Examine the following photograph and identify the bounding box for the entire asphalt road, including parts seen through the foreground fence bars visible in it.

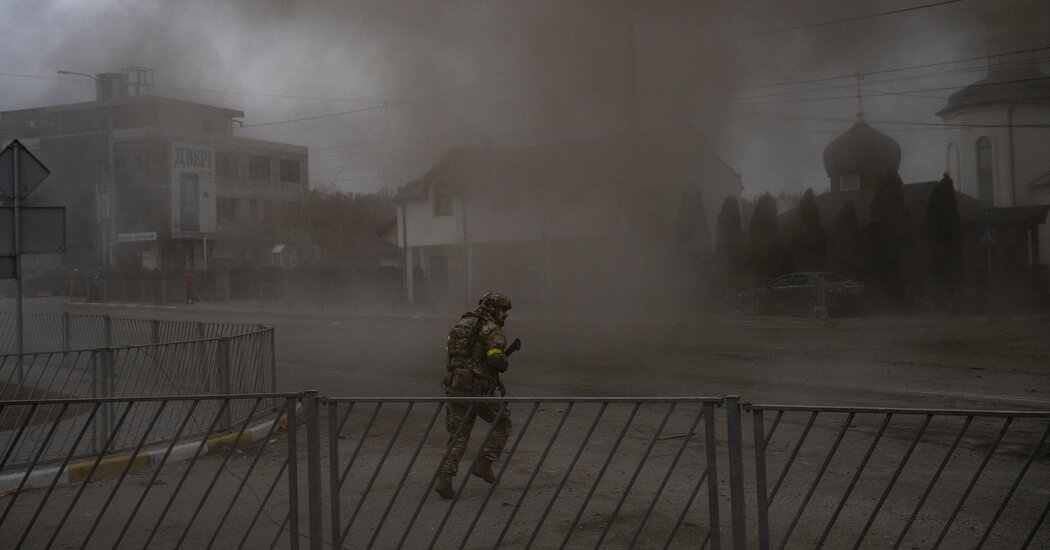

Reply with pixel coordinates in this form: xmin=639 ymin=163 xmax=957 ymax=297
xmin=0 ymin=298 xmax=1050 ymax=547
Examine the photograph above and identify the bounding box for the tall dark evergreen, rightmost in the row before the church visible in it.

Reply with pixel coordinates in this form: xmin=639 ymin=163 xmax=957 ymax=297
xmin=926 ymin=174 xmax=963 ymax=306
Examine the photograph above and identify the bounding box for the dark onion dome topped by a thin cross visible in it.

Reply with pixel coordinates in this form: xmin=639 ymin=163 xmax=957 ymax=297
xmin=824 ymin=120 xmax=901 ymax=181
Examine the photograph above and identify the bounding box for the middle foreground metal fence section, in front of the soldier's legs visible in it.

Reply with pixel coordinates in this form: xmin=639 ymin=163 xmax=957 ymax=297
xmin=323 ymin=398 xmax=721 ymax=548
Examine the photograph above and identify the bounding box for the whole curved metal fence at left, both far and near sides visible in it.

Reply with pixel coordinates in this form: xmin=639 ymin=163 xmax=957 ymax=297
xmin=0 ymin=314 xmax=276 ymax=468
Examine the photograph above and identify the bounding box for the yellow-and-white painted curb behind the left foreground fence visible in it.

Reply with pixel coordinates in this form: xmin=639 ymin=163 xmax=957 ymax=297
xmin=0 ymin=407 xmax=288 ymax=498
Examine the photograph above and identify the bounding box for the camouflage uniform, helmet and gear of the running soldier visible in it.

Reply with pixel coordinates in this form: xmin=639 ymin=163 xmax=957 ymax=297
xmin=438 ymin=293 xmax=510 ymax=482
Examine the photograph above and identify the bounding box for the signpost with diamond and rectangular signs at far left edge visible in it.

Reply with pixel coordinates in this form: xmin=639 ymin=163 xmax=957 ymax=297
xmin=0 ymin=140 xmax=65 ymax=361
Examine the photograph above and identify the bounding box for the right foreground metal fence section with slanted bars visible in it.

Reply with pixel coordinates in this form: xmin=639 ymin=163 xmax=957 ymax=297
xmin=746 ymin=405 xmax=1050 ymax=549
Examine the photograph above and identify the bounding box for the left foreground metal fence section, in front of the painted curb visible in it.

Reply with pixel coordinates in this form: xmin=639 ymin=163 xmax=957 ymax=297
xmin=0 ymin=394 xmax=300 ymax=548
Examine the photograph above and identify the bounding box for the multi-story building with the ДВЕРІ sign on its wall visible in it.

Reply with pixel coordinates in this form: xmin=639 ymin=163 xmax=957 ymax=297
xmin=0 ymin=68 xmax=309 ymax=287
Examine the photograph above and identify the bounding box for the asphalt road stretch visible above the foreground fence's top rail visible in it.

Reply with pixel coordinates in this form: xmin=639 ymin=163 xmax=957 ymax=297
xmin=25 ymin=298 xmax=1050 ymax=409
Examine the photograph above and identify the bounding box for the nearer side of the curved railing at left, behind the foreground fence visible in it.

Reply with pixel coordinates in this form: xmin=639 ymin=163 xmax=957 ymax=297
xmin=0 ymin=329 xmax=276 ymax=467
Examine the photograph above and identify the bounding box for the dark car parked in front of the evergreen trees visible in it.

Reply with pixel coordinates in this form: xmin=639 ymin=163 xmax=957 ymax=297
xmin=739 ymin=272 xmax=864 ymax=314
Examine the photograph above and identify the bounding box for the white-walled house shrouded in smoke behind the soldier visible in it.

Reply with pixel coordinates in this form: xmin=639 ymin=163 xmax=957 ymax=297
xmin=396 ymin=125 xmax=741 ymax=313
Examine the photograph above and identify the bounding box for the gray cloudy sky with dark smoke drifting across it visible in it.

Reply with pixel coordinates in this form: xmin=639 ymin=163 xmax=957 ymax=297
xmin=0 ymin=0 xmax=1050 ymax=195
